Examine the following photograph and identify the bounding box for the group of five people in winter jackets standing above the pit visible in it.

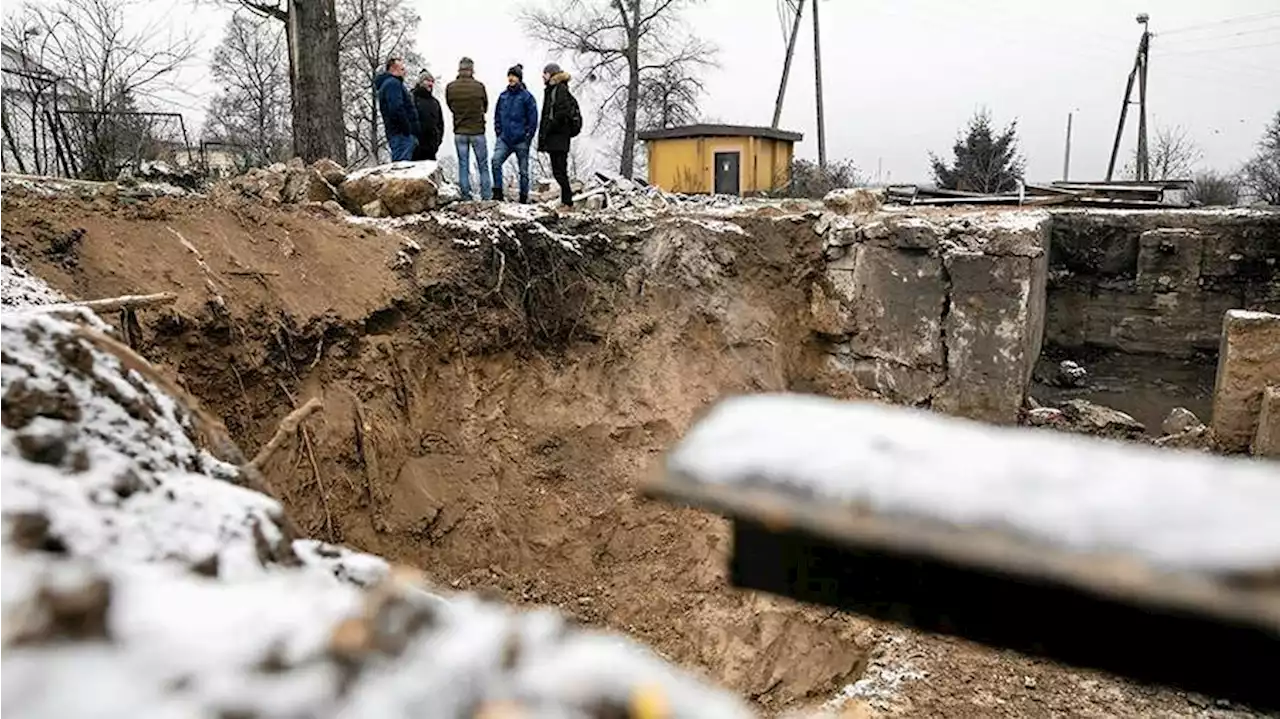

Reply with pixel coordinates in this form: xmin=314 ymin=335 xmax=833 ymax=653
xmin=374 ymin=58 xmax=582 ymax=207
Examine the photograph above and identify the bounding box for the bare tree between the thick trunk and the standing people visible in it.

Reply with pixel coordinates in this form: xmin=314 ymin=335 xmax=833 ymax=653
xmin=338 ymin=0 xmax=422 ymax=165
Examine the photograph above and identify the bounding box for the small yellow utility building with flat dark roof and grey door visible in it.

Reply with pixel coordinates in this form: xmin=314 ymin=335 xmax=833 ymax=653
xmin=639 ymin=125 xmax=804 ymax=194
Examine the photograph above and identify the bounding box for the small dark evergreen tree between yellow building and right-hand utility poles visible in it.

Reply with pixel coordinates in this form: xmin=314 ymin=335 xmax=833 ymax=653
xmin=929 ymin=110 xmax=1027 ymax=192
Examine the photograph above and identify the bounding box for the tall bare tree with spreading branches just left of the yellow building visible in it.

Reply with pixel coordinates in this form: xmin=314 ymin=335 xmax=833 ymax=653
xmin=521 ymin=0 xmax=717 ymax=177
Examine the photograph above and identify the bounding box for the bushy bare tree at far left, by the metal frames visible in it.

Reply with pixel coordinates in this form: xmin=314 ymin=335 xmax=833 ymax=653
xmin=20 ymin=0 xmax=196 ymax=179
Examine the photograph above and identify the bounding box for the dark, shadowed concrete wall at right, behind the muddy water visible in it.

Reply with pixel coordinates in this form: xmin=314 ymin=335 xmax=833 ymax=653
xmin=1046 ymin=210 xmax=1280 ymax=357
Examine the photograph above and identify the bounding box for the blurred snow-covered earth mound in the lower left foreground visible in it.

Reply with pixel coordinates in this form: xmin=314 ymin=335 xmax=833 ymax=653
xmin=0 ymin=255 xmax=751 ymax=719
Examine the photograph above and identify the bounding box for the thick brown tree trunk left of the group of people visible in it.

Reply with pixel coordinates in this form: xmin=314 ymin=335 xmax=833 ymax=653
xmin=285 ymin=0 xmax=347 ymax=165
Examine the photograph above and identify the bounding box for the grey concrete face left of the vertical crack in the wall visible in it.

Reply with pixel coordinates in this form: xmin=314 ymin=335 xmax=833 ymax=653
xmin=827 ymin=244 xmax=946 ymax=367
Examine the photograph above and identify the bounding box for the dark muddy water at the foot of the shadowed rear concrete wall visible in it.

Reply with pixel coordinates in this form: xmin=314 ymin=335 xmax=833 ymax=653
xmin=1030 ymin=352 xmax=1216 ymax=435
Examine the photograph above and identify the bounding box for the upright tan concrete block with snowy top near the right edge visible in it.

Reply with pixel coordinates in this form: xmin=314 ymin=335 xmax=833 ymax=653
xmin=1212 ymin=310 xmax=1280 ymax=452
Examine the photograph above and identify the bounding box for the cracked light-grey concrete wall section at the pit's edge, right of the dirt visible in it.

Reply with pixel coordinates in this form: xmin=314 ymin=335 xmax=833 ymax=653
xmin=812 ymin=211 xmax=1050 ymax=423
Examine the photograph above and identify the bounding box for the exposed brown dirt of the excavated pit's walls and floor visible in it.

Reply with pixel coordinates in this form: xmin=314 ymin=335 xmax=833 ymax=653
xmin=0 ymin=188 xmax=1259 ymax=716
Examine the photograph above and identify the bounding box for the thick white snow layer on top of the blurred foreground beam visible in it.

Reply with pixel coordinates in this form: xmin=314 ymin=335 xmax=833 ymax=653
xmin=668 ymin=394 xmax=1280 ymax=572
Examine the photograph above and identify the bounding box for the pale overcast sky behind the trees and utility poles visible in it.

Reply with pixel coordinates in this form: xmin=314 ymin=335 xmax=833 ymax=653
xmin=165 ymin=0 xmax=1280 ymax=182
